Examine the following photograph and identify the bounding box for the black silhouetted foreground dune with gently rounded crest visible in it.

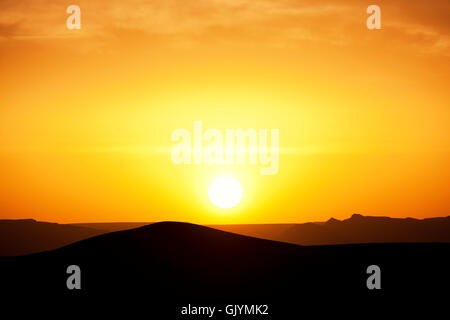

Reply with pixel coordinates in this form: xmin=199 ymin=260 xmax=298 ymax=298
xmin=0 ymin=222 xmax=450 ymax=320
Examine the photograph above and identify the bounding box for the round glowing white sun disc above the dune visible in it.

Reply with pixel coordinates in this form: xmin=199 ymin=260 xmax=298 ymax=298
xmin=208 ymin=176 xmax=242 ymax=209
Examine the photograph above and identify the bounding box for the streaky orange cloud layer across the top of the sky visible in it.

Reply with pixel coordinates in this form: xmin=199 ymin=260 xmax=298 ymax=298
xmin=0 ymin=0 xmax=450 ymax=55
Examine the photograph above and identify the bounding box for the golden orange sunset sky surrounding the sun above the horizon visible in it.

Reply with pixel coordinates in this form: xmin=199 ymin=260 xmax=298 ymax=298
xmin=0 ymin=0 xmax=450 ymax=224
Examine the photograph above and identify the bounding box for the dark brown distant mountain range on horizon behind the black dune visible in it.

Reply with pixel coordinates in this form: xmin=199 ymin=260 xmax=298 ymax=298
xmin=0 ymin=214 xmax=450 ymax=256
